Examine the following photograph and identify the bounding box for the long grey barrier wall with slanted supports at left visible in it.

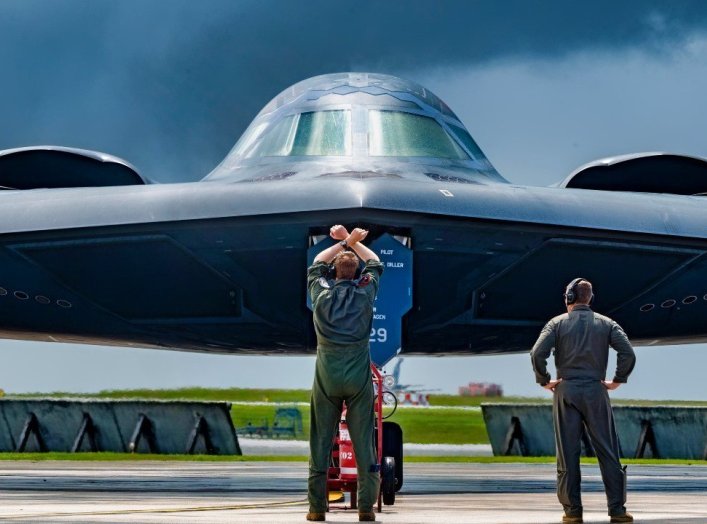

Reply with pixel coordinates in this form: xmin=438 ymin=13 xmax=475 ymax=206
xmin=0 ymin=399 xmax=242 ymax=455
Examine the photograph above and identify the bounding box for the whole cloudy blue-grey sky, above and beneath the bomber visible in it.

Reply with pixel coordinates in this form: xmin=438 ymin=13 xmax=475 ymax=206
xmin=0 ymin=0 xmax=707 ymax=392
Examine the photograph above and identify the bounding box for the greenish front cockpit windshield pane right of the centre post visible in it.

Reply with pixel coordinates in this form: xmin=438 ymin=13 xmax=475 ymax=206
xmin=368 ymin=110 xmax=469 ymax=160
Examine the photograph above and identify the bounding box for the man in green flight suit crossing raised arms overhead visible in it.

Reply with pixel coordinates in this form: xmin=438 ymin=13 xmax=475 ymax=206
xmin=307 ymin=226 xmax=383 ymax=521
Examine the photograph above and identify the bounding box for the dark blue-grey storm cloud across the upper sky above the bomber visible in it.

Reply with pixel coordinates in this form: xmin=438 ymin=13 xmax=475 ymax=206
xmin=0 ymin=0 xmax=707 ymax=181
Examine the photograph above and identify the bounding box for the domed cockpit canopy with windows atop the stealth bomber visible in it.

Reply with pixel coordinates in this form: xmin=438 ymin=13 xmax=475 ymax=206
xmin=207 ymin=73 xmax=502 ymax=180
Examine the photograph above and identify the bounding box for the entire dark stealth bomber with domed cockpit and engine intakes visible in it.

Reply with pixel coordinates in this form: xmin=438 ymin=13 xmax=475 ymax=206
xmin=0 ymin=73 xmax=707 ymax=358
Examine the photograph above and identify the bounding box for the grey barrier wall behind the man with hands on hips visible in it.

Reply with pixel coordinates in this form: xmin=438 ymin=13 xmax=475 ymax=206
xmin=481 ymin=404 xmax=707 ymax=460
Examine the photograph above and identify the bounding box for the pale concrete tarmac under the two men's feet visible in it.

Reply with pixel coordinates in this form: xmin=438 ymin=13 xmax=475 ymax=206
xmin=0 ymin=461 xmax=707 ymax=524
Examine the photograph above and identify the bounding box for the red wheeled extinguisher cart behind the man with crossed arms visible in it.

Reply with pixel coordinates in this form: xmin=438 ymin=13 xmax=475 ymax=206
xmin=327 ymin=365 xmax=403 ymax=513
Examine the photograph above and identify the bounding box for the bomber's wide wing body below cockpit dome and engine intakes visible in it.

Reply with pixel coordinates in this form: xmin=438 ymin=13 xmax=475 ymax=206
xmin=0 ymin=174 xmax=707 ymax=354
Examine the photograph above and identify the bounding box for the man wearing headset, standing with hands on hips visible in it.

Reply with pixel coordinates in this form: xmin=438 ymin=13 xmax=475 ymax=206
xmin=530 ymin=278 xmax=636 ymax=523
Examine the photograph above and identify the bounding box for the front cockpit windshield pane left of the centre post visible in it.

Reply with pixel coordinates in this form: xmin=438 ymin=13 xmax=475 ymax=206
xmin=247 ymin=110 xmax=351 ymax=158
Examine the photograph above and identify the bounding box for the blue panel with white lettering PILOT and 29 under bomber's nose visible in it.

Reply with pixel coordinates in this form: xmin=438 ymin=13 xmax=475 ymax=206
xmin=307 ymin=233 xmax=412 ymax=366
